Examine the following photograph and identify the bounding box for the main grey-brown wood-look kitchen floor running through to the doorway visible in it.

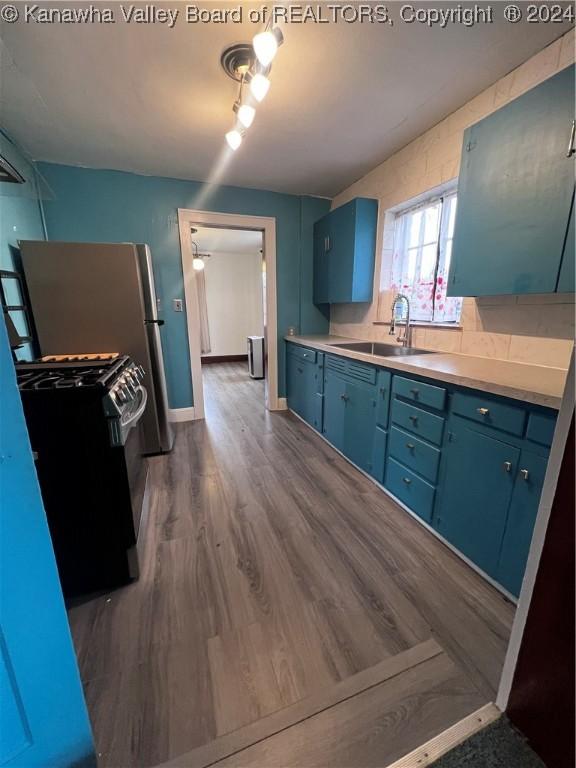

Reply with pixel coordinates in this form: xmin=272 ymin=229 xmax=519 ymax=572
xmin=69 ymin=363 xmax=513 ymax=768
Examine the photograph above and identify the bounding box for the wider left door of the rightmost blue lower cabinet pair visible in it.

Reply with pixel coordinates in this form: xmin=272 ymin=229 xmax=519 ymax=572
xmin=433 ymin=417 xmax=520 ymax=578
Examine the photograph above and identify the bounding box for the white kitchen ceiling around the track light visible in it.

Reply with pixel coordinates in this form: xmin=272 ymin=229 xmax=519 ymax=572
xmin=0 ymin=2 xmax=567 ymax=197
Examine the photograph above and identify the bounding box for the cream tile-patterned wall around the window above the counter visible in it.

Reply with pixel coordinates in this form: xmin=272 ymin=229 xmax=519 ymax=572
xmin=330 ymin=29 xmax=574 ymax=368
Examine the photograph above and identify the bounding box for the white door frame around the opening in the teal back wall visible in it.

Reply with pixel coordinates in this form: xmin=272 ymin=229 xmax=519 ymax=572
xmin=178 ymin=208 xmax=282 ymax=419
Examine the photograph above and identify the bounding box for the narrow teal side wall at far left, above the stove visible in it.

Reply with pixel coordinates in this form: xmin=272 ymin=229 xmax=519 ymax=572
xmin=0 ymin=133 xmax=45 ymax=270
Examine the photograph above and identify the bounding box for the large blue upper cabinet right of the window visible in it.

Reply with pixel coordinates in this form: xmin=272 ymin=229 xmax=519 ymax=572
xmin=448 ymin=66 xmax=574 ymax=296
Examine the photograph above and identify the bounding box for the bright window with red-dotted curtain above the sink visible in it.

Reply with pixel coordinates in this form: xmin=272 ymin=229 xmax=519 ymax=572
xmin=390 ymin=192 xmax=462 ymax=323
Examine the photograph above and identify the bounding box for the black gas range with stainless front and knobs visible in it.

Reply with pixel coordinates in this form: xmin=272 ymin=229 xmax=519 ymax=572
xmin=16 ymin=353 xmax=148 ymax=597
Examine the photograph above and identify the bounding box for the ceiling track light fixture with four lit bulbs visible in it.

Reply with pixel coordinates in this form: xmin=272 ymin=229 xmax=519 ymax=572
xmin=220 ymin=23 xmax=284 ymax=151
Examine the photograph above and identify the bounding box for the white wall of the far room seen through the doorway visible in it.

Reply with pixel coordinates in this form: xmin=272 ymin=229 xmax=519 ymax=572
xmin=205 ymin=252 xmax=264 ymax=357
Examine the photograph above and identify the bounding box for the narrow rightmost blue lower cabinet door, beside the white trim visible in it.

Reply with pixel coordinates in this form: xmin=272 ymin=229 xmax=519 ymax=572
xmin=497 ymin=450 xmax=548 ymax=596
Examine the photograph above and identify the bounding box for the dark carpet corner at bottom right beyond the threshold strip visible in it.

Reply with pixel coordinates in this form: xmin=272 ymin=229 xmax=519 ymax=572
xmin=431 ymin=717 xmax=546 ymax=768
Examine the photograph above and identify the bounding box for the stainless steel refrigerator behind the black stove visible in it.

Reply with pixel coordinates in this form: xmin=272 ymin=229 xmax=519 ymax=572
xmin=19 ymin=240 xmax=174 ymax=454
